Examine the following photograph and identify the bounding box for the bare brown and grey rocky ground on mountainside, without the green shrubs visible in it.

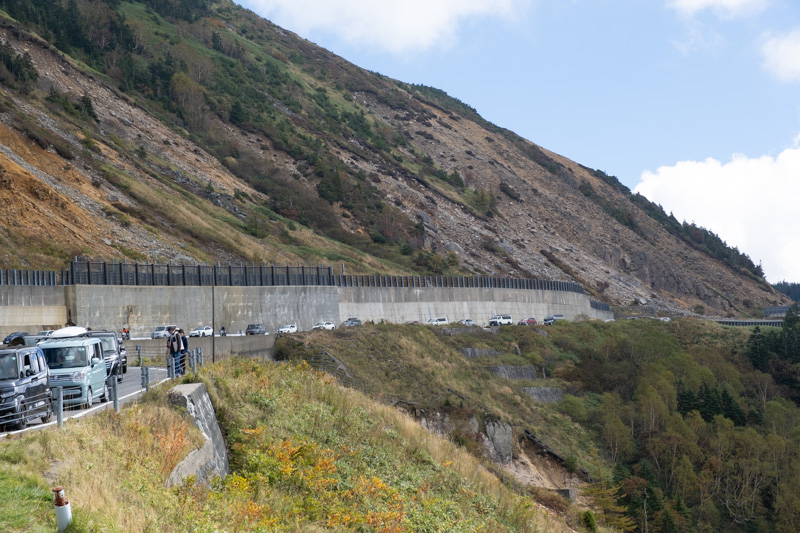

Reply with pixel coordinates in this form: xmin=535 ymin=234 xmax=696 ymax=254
xmin=0 ymin=15 xmax=790 ymax=315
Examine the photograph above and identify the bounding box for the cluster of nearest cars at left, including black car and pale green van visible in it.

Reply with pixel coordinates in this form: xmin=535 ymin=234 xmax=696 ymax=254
xmin=0 ymin=327 xmax=128 ymax=429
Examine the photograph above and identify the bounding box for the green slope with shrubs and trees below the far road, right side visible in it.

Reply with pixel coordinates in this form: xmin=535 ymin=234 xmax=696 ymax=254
xmin=276 ymin=318 xmax=800 ymax=532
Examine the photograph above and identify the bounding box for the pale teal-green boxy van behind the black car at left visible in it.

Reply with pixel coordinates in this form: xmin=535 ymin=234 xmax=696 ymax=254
xmin=38 ymin=337 xmax=109 ymax=407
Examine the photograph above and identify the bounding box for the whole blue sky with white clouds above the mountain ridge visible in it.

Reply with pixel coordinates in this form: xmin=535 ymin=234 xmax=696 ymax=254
xmin=236 ymin=0 xmax=800 ymax=283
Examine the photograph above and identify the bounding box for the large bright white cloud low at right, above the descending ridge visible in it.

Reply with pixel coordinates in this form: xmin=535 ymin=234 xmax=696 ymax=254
xmin=634 ymin=141 xmax=800 ymax=283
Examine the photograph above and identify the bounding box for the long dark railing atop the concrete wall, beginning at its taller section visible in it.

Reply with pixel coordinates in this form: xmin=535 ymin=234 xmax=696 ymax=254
xmin=61 ymin=258 xmax=588 ymax=296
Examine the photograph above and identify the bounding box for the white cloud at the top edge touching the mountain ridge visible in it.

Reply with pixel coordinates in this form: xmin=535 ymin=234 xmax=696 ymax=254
xmin=240 ymin=0 xmax=530 ymax=54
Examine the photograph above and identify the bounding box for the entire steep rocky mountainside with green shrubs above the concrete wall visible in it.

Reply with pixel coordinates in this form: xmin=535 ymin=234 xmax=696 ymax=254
xmin=0 ymin=0 xmax=789 ymax=316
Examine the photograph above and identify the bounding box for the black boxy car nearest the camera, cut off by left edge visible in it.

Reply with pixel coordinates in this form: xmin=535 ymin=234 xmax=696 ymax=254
xmin=0 ymin=346 xmax=53 ymax=429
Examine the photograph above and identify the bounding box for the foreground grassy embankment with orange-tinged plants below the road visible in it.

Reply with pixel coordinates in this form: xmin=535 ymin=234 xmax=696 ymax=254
xmin=0 ymin=360 xmax=584 ymax=531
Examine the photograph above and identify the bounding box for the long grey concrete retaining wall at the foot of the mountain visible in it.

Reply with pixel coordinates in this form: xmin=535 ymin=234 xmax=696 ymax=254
xmin=0 ymin=285 xmax=612 ymax=337
